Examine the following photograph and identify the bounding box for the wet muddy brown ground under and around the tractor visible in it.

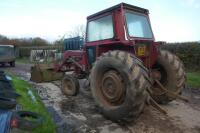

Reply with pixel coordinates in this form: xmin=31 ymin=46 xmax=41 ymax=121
xmin=0 ymin=64 xmax=200 ymax=133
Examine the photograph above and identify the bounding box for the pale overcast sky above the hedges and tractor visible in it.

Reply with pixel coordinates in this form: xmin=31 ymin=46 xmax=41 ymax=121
xmin=0 ymin=0 xmax=200 ymax=42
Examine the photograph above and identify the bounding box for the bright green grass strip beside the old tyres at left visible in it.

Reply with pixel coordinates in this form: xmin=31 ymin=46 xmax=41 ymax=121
xmin=12 ymin=75 xmax=56 ymax=133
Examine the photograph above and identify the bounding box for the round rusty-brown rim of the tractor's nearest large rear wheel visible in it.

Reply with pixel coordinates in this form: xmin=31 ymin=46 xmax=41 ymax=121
xmin=100 ymin=70 xmax=125 ymax=105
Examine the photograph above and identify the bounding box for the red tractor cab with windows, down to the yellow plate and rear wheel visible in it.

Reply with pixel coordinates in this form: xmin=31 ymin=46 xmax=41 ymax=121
xmin=86 ymin=3 xmax=154 ymax=65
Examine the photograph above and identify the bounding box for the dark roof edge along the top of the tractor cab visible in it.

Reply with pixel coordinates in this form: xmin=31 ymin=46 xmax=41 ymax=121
xmin=87 ymin=3 xmax=149 ymax=19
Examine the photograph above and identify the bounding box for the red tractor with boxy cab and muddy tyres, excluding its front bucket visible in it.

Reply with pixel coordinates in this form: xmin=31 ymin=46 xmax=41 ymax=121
xmin=55 ymin=3 xmax=186 ymax=121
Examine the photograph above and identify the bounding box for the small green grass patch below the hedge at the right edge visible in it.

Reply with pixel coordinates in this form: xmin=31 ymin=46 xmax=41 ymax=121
xmin=187 ymin=72 xmax=200 ymax=88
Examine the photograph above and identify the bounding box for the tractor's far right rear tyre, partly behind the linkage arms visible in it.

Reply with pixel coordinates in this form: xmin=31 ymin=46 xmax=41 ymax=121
xmin=152 ymin=50 xmax=186 ymax=104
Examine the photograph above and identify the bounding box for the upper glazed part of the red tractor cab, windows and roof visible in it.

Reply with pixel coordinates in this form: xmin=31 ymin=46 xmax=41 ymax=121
xmin=86 ymin=3 xmax=154 ymax=43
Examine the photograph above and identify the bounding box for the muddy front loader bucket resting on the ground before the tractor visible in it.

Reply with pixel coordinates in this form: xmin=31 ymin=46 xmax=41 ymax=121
xmin=30 ymin=65 xmax=64 ymax=83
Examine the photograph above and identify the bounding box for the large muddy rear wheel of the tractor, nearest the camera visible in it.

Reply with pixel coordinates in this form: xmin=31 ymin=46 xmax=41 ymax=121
xmin=90 ymin=51 xmax=149 ymax=121
